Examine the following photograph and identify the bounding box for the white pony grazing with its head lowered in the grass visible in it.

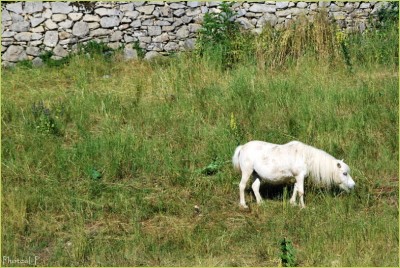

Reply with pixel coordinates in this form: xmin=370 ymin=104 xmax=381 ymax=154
xmin=232 ymin=141 xmax=355 ymax=208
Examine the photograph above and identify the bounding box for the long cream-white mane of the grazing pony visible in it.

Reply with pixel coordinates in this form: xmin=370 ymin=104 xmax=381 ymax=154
xmin=296 ymin=142 xmax=337 ymax=187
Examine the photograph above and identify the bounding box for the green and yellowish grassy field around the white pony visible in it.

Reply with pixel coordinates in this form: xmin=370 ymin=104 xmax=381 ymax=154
xmin=1 ymin=15 xmax=399 ymax=266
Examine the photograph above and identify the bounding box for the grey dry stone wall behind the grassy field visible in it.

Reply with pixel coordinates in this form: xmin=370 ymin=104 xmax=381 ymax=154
xmin=1 ymin=1 xmax=387 ymax=66
